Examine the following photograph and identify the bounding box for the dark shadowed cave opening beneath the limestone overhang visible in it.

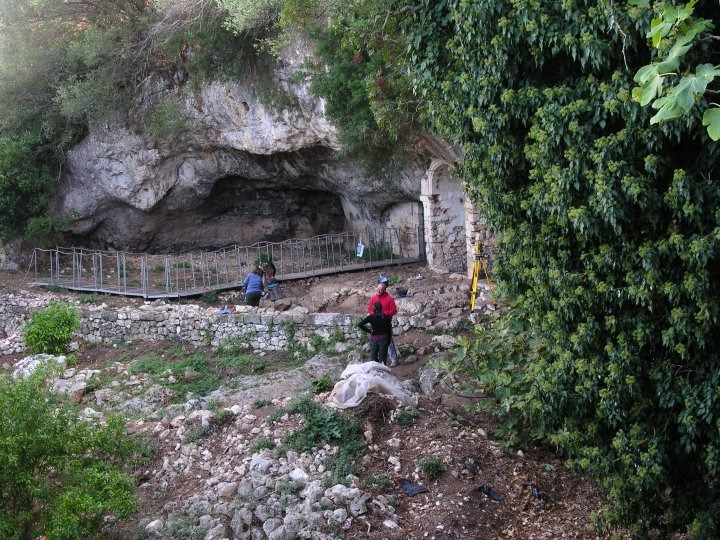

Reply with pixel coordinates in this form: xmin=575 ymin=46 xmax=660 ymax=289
xmin=198 ymin=177 xmax=345 ymax=247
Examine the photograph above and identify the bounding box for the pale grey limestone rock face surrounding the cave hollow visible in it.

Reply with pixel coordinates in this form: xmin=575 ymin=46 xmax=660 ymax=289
xmin=60 ymin=39 xmax=427 ymax=252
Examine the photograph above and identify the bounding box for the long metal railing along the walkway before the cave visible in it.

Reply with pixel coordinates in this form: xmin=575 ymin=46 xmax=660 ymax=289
xmin=29 ymin=227 xmax=425 ymax=298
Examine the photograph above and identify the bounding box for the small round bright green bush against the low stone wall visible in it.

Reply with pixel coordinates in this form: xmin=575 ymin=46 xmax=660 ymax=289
xmin=23 ymin=301 xmax=80 ymax=354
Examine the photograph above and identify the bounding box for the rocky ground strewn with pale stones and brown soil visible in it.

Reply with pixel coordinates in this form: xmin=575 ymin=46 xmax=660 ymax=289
xmin=0 ymin=265 xmax=602 ymax=539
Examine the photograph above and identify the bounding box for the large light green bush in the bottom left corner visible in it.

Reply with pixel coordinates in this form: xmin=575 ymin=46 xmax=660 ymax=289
xmin=0 ymin=372 xmax=141 ymax=540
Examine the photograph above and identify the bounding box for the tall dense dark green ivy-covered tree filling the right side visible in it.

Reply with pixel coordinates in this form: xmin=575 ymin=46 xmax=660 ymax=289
xmin=407 ymin=0 xmax=720 ymax=538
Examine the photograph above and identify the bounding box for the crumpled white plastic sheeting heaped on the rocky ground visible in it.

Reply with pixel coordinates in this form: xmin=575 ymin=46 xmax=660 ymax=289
xmin=328 ymin=362 xmax=417 ymax=409
